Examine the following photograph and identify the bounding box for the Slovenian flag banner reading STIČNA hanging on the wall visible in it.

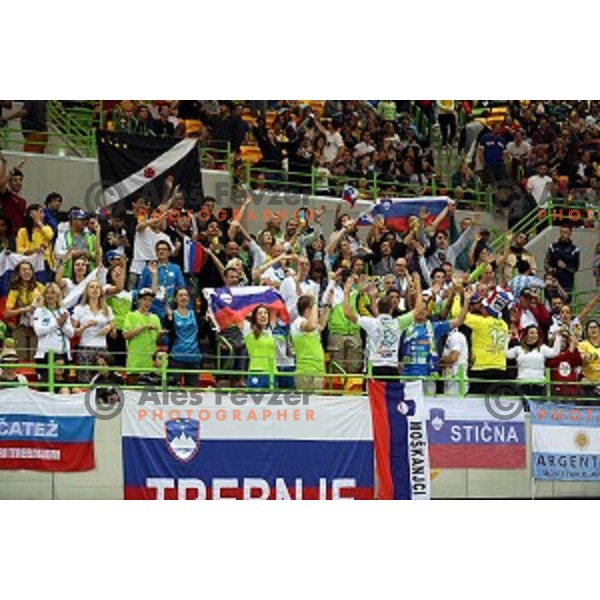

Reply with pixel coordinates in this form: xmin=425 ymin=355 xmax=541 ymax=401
xmin=427 ymin=397 xmax=527 ymax=469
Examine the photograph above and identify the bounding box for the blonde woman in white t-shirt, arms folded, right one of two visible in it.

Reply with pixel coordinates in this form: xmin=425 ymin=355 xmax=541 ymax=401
xmin=73 ymin=279 xmax=116 ymax=383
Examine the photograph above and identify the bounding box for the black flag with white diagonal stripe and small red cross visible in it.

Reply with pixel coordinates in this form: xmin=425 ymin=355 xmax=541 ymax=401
xmin=96 ymin=130 xmax=204 ymax=210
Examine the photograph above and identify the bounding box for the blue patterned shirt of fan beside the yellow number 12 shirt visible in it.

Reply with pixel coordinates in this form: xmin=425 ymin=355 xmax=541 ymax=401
xmin=402 ymin=321 xmax=452 ymax=377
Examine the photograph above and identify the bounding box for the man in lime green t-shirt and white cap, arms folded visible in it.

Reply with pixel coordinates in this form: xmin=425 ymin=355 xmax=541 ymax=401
xmin=123 ymin=288 xmax=161 ymax=381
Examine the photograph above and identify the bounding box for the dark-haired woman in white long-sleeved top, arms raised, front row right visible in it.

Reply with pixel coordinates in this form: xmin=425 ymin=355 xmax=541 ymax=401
xmin=506 ymin=325 xmax=561 ymax=399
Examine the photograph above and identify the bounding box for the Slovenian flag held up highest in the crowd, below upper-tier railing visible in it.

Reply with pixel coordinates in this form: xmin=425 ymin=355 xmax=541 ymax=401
xmin=356 ymin=196 xmax=450 ymax=232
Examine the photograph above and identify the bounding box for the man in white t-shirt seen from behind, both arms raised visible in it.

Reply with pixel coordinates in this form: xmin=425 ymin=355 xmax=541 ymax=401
xmin=344 ymin=275 xmax=422 ymax=377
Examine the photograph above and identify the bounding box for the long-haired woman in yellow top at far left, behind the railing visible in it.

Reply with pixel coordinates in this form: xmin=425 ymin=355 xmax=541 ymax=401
xmin=4 ymin=260 xmax=44 ymax=363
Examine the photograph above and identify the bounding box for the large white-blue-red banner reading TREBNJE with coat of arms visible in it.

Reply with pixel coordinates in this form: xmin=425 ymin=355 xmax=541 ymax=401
xmin=123 ymin=391 xmax=374 ymax=500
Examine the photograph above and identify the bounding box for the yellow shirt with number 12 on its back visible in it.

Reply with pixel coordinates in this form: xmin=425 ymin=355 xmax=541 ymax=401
xmin=465 ymin=313 xmax=508 ymax=371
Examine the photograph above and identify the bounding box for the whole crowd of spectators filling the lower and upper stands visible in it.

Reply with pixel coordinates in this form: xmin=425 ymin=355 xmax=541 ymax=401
xmin=0 ymin=101 xmax=600 ymax=404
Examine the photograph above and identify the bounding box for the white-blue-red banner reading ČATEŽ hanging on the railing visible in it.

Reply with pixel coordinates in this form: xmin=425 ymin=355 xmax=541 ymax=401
xmin=0 ymin=387 xmax=95 ymax=471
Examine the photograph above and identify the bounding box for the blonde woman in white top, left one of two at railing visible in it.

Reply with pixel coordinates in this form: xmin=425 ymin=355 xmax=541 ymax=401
xmin=33 ymin=283 xmax=74 ymax=381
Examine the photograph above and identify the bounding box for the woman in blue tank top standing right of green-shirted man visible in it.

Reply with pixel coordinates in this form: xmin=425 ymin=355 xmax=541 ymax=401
xmin=166 ymin=287 xmax=206 ymax=387
